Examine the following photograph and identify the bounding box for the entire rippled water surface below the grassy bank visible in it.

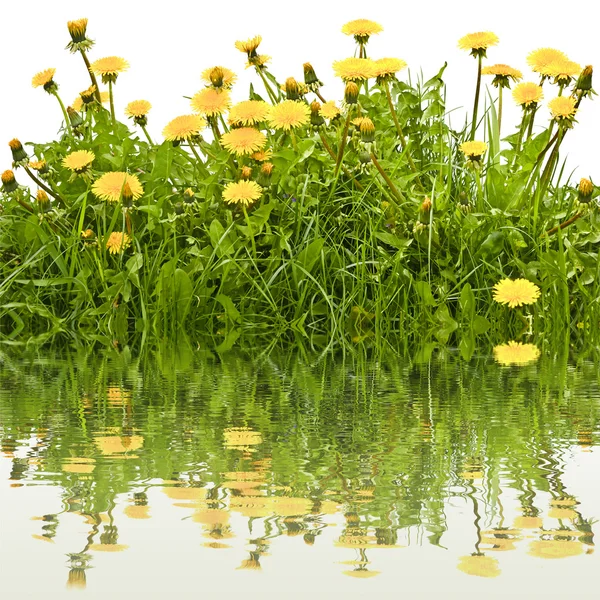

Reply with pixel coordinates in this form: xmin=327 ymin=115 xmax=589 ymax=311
xmin=0 ymin=348 xmax=600 ymax=599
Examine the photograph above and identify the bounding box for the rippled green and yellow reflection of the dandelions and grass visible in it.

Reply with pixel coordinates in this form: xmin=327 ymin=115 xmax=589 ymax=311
xmin=0 ymin=346 xmax=600 ymax=589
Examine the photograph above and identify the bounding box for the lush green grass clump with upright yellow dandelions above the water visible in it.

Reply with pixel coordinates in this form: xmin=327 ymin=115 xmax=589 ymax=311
xmin=0 ymin=19 xmax=600 ymax=357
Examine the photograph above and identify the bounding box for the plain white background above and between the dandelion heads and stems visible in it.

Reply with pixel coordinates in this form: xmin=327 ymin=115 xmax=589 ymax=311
xmin=0 ymin=0 xmax=600 ymax=183
